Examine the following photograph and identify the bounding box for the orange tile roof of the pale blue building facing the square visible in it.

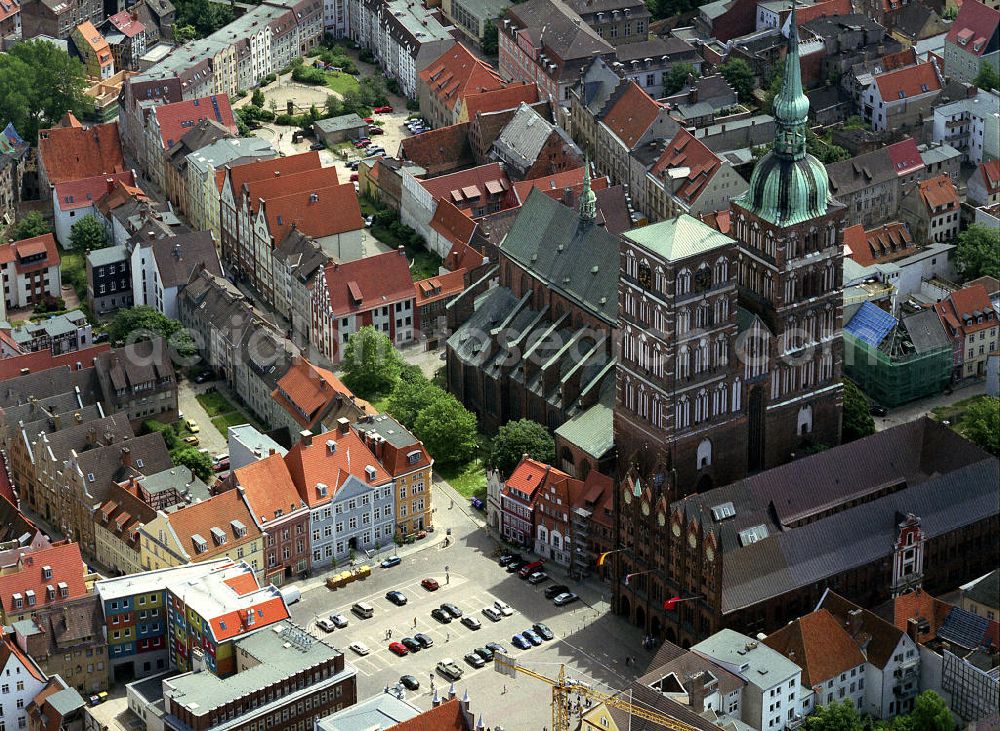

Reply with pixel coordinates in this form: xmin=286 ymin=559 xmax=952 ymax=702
xmin=285 ymin=429 xmax=392 ymax=508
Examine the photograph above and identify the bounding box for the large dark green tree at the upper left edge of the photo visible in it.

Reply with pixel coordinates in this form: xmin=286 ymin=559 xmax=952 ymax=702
xmin=0 ymin=40 xmax=93 ymax=140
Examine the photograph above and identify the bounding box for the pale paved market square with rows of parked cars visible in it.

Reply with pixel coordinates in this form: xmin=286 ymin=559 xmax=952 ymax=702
xmin=291 ymin=484 xmax=648 ymax=731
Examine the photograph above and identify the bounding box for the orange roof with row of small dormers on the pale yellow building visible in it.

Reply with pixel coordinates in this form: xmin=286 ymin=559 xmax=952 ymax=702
xmin=166 ymin=490 xmax=262 ymax=561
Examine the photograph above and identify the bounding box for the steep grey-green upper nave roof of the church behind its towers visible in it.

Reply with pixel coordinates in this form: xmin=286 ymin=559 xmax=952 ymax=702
xmin=500 ymin=189 xmax=618 ymax=323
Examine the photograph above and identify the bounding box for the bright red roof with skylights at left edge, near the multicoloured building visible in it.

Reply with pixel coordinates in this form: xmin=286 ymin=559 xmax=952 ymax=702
xmin=0 ymin=543 xmax=87 ymax=621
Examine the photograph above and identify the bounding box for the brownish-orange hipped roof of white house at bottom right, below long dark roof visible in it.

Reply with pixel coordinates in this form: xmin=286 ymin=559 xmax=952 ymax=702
xmin=764 ymin=609 xmax=865 ymax=688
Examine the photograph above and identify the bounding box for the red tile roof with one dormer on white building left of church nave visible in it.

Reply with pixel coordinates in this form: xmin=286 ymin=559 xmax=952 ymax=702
xmin=325 ymin=250 xmax=413 ymax=317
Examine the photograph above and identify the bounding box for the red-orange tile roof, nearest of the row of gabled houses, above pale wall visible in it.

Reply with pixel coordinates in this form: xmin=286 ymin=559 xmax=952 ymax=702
xmin=264 ymin=182 xmax=365 ymax=246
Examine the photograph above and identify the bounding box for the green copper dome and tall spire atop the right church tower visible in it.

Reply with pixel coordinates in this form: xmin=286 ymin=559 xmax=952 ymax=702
xmin=735 ymin=0 xmax=830 ymax=226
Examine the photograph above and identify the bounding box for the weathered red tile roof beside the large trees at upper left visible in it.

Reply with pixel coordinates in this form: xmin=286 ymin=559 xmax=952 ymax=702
xmin=38 ymin=122 xmax=126 ymax=185
